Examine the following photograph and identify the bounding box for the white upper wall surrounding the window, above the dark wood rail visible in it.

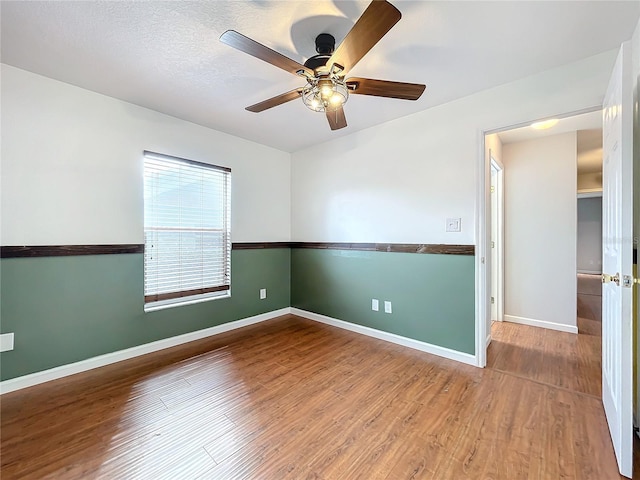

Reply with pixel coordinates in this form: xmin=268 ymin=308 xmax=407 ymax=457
xmin=1 ymin=65 xmax=291 ymax=245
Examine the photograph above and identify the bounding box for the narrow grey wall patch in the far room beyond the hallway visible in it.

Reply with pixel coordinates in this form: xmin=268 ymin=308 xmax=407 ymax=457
xmin=577 ymin=197 xmax=602 ymax=274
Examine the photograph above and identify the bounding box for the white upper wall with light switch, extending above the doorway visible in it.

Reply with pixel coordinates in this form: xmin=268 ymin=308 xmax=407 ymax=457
xmin=292 ymin=51 xmax=616 ymax=244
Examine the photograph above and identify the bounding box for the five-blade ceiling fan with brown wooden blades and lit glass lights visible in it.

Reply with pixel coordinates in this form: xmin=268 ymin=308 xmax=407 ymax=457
xmin=220 ymin=0 xmax=425 ymax=130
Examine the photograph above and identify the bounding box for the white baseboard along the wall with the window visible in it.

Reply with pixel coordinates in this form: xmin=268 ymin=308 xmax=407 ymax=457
xmin=0 ymin=307 xmax=291 ymax=395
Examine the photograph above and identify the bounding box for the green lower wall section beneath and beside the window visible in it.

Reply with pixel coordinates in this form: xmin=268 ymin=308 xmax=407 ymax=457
xmin=0 ymin=248 xmax=291 ymax=380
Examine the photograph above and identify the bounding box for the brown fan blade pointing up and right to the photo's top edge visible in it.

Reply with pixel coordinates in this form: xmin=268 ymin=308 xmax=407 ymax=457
xmin=327 ymin=0 xmax=402 ymax=75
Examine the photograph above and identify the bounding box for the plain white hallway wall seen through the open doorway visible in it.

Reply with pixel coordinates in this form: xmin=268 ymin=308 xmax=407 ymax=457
xmin=502 ymin=132 xmax=577 ymax=330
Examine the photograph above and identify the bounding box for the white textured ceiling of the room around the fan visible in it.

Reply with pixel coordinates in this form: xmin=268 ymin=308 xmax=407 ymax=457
xmin=0 ymin=0 xmax=640 ymax=151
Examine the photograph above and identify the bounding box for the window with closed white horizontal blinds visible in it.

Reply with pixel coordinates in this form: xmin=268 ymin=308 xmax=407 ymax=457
xmin=144 ymin=151 xmax=231 ymax=310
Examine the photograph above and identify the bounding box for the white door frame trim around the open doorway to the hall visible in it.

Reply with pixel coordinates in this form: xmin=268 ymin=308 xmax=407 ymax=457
xmin=475 ymin=105 xmax=602 ymax=368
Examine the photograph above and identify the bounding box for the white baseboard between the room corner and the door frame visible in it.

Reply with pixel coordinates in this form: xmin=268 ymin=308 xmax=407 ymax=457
xmin=291 ymin=307 xmax=477 ymax=366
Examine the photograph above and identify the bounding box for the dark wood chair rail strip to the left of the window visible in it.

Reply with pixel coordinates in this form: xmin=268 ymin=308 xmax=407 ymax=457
xmin=0 ymin=243 xmax=144 ymax=258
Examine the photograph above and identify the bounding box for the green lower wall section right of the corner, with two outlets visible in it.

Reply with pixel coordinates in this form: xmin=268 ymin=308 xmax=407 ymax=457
xmin=291 ymin=248 xmax=475 ymax=355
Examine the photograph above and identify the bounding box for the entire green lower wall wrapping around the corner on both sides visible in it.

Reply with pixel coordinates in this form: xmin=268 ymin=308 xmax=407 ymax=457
xmin=0 ymin=248 xmax=475 ymax=380
